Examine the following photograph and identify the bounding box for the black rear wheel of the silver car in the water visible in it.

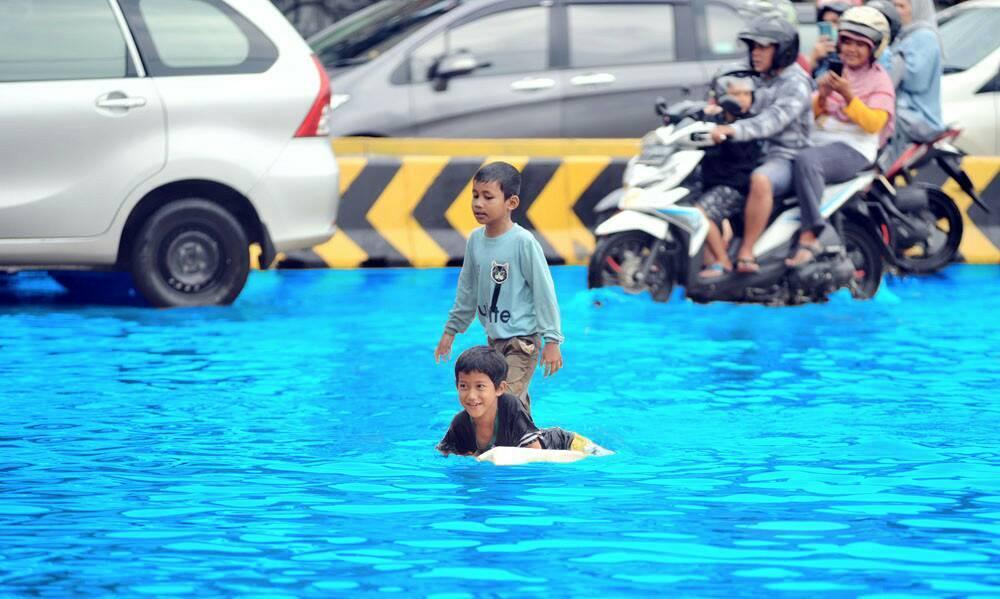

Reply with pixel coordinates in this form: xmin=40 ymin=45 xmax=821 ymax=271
xmin=130 ymin=198 xmax=250 ymax=308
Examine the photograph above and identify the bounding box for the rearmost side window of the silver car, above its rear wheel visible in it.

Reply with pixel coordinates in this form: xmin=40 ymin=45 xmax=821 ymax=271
xmin=122 ymin=0 xmax=278 ymax=76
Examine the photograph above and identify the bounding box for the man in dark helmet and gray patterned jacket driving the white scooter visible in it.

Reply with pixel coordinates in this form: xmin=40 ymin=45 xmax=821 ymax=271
xmin=711 ymin=16 xmax=813 ymax=273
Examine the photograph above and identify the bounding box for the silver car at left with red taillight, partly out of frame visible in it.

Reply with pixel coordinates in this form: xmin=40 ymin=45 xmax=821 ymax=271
xmin=0 ymin=0 xmax=338 ymax=306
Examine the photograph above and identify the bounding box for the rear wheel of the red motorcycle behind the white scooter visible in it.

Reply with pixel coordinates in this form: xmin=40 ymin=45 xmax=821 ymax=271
xmin=896 ymin=187 xmax=964 ymax=275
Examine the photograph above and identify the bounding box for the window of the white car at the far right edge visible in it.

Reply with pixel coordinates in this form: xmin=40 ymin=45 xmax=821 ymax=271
xmin=938 ymin=7 xmax=1000 ymax=73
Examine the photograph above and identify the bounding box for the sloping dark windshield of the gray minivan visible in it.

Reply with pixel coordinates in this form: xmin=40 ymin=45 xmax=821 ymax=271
xmin=309 ymin=0 xmax=459 ymax=69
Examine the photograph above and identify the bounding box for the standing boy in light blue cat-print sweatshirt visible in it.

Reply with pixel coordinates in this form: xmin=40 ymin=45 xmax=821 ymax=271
xmin=434 ymin=162 xmax=563 ymax=414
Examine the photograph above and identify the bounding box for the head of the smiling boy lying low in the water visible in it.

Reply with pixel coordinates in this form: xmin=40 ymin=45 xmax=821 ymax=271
xmin=455 ymin=345 xmax=507 ymax=420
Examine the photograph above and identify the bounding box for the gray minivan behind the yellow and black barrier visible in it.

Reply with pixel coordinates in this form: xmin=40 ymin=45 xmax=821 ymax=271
xmin=308 ymin=0 xmax=746 ymax=137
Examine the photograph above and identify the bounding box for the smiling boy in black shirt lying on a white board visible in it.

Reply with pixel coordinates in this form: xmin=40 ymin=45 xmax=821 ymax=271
xmin=437 ymin=345 xmax=592 ymax=455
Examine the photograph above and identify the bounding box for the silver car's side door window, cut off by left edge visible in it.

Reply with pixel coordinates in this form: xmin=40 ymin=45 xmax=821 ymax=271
xmin=0 ymin=0 xmax=128 ymax=81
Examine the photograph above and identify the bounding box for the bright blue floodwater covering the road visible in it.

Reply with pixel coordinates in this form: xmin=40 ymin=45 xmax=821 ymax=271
xmin=0 ymin=266 xmax=1000 ymax=598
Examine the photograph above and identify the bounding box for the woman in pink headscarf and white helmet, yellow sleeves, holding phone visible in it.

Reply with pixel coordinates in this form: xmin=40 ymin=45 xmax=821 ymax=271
xmin=786 ymin=6 xmax=896 ymax=266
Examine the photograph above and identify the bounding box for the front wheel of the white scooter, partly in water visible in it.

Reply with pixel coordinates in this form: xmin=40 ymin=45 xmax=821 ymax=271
xmin=587 ymin=231 xmax=674 ymax=302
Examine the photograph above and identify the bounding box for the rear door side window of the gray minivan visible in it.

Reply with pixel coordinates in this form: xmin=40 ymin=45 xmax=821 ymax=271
xmin=568 ymin=4 xmax=676 ymax=68
